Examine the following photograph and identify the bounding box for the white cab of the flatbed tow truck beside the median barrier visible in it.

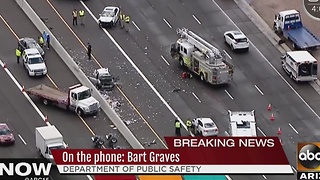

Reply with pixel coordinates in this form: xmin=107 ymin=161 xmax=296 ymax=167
xmin=68 ymin=84 xmax=100 ymax=115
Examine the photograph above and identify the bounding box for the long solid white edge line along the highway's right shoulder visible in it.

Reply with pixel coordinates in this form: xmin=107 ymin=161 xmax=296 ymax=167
xmin=211 ymin=0 xmax=320 ymax=122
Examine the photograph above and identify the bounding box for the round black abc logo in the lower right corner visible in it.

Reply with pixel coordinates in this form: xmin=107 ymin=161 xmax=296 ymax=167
xmin=298 ymin=144 xmax=320 ymax=169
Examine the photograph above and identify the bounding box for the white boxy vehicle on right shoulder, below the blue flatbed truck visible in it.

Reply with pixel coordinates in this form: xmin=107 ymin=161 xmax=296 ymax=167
xmin=281 ymin=51 xmax=318 ymax=82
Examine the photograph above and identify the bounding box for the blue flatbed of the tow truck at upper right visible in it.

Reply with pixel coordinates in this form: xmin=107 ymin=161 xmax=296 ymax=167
xmin=284 ymin=27 xmax=320 ymax=49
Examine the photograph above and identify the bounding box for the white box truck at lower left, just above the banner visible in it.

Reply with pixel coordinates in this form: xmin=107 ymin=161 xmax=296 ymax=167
xmin=36 ymin=126 xmax=68 ymax=163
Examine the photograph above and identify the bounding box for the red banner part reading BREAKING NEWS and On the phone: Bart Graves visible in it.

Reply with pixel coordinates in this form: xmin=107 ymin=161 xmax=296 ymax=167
xmin=52 ymin=137 xmax=289 ymax=165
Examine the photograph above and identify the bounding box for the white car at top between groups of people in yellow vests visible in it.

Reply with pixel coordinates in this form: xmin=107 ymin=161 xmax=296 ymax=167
xmin=98 ymin=6 xmax=120 ymax=28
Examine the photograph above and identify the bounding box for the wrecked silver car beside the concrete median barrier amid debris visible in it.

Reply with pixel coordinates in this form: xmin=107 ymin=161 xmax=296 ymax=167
xmin=93 ymin=68 xmax=115 ymax=90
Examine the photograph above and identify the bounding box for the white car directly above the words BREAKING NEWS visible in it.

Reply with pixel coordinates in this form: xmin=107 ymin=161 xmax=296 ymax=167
xmin=192 ymin=118 xmax=219 ymax=136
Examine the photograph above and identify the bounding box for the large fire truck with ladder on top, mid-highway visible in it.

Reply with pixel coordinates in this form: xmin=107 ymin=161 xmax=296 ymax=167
xmin=170 ymin=28 xmax=233 ymax=85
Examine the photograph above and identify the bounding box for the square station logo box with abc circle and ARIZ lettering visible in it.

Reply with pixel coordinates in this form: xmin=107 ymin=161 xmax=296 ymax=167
xmin=297 ymin=142 xmax=320 ymax=180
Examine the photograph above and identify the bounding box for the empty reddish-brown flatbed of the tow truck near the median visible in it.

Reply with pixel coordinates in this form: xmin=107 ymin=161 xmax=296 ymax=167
xmin=26 ymin=84 xmax=68 ymax=104
